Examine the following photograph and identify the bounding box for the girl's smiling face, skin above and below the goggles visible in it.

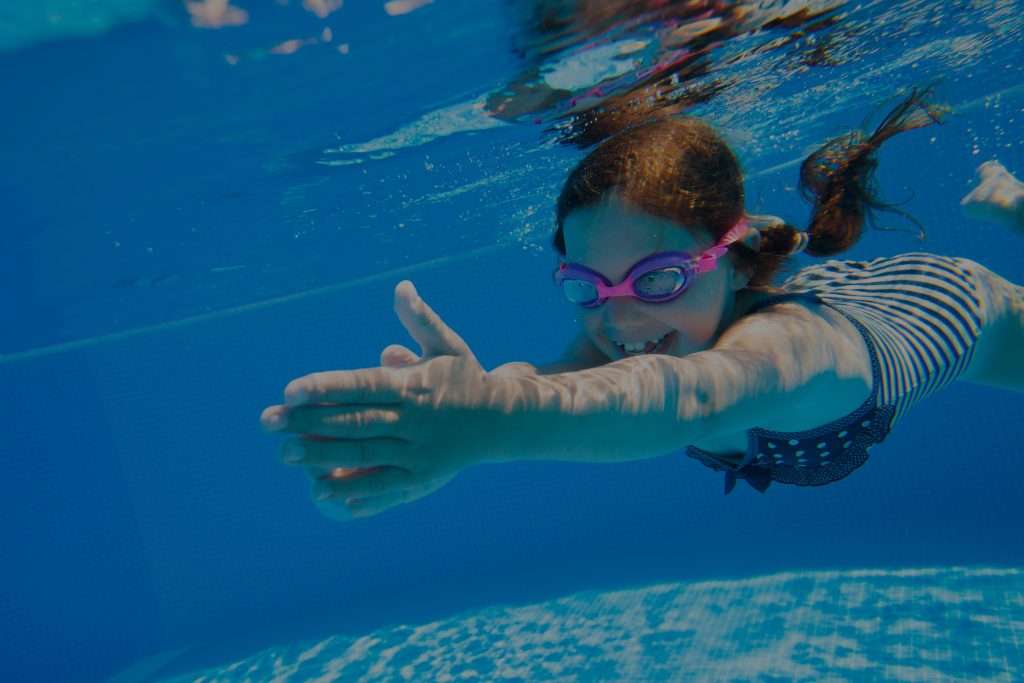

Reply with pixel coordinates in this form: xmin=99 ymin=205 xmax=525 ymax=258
xmin=562 ymin=195 xmax=746 ymax=360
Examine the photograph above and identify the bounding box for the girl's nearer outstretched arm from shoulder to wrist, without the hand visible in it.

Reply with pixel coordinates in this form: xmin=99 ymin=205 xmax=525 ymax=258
xmin=486 ymin=303 xmax=871 ymax=462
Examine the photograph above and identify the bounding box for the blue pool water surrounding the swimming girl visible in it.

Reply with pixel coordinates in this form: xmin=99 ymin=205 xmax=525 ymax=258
xmin=0 ymin=0 xmax=1024 ymax=683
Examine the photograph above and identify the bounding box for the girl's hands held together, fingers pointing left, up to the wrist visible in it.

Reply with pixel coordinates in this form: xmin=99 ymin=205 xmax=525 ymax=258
xmin=261 ymin=281 xmax=501 ymax=519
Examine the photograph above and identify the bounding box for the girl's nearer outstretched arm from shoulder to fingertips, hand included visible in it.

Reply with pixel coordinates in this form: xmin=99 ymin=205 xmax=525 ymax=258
xmin=263 ymin=284 xmax=870 ymax=475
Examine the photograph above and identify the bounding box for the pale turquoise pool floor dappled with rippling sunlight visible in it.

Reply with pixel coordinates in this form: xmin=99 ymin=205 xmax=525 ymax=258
xmin=153 ymin=567 xmax=1024 ymax=683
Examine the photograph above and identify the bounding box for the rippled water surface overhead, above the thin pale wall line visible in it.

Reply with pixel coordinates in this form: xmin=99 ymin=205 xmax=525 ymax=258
xmin=0 ymin=0 xmax=1024 ymax=360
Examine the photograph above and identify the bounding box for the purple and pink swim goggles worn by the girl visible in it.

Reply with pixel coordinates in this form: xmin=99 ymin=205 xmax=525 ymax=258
xmin=554 ymin=218 xmax=749 ymax=308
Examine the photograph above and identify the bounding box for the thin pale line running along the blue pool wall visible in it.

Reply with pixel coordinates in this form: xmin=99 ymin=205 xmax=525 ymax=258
xmin=0 ymin=85 xmax=1024 ymax=366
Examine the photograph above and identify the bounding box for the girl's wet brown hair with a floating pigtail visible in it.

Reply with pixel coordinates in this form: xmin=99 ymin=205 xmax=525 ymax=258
xmin=553 ymin=88 xmax=948 ymax=288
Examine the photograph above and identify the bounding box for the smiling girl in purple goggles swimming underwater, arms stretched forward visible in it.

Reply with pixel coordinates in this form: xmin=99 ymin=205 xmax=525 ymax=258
xmin=262 ymin=90 xmax=1024 ymax=518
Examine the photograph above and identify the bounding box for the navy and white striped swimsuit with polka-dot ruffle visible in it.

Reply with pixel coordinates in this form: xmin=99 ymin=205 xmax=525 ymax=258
xmin=686 ymin=253 xmax=982 ymax=494
